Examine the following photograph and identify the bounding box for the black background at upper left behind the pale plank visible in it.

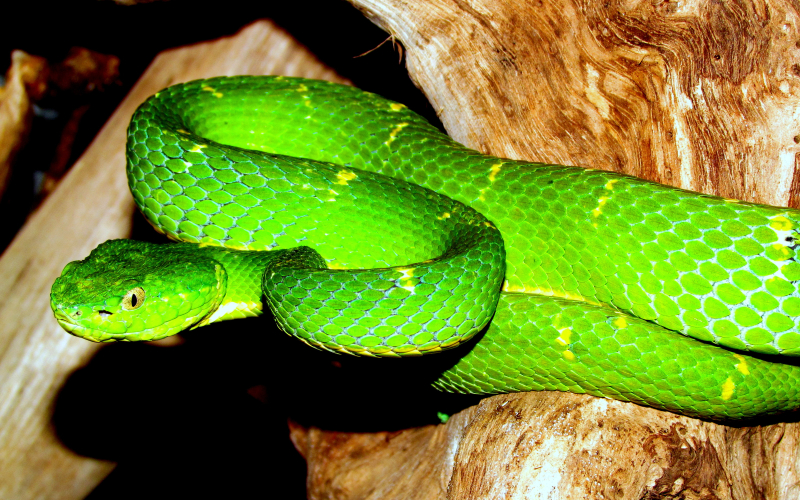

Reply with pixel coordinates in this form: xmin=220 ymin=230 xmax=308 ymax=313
xmin=0 ymin=0 xmax=440 ymax=250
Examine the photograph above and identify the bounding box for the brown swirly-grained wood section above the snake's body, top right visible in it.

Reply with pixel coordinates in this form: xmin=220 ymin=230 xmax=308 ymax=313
xmin=351 ymin=0 xmax=800 ymax=206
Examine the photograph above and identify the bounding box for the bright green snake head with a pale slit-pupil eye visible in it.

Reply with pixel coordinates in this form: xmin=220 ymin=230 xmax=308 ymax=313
xmin=50 ymin=240 xmax=227 ymax=342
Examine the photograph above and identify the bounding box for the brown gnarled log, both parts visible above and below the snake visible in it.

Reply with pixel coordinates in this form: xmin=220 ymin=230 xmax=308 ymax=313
xmin=292 ymin=0 xmax=800 ymax=500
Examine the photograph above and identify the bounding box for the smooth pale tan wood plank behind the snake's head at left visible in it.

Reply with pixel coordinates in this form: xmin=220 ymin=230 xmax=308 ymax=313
xmin=0 ymin=21 xmax=341 ymax=500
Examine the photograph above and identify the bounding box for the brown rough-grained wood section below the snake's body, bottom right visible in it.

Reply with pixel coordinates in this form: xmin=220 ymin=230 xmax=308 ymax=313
xmin=291 ymin=392 xmax=800 ymax=500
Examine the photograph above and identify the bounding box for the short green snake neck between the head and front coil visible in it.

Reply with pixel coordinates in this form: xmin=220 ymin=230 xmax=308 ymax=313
xmin=197 ymin=247 xmax=273 ymax=327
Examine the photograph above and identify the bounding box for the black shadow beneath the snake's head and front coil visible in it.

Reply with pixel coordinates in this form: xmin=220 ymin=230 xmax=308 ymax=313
xmin=52 ymin=308 xmax=478 ymax=500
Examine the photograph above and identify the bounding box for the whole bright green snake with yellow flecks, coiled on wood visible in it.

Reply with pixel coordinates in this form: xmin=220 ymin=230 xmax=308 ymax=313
xmin=51 ymin=76 xmax=800 ymax=419
